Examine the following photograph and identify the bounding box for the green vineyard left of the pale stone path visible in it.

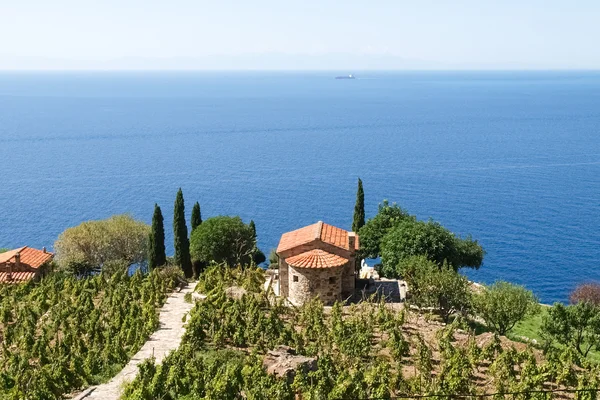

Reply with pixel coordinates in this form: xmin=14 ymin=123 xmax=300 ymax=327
xmin=0 ymin=268 xmax=180 ymax=399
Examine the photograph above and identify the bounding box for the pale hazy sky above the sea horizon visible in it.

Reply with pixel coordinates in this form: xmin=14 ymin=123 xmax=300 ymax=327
xmin=0 ymin=0 xmax=600 ymax=70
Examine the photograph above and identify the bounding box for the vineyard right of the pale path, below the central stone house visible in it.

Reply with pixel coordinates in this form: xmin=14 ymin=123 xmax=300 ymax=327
xmin=123 ymin=268 xmax=600 ymax=400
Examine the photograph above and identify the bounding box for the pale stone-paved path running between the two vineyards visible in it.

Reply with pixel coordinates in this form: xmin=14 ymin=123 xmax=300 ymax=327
xmin=76 ymin=283 xmax=196 ymax=400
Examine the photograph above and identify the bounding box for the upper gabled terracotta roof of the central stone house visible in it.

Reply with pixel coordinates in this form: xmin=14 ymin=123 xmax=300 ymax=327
xmin=277 ymin=221 xmax=358 ymax=253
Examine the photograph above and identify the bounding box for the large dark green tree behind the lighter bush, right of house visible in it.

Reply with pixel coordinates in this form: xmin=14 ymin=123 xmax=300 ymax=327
xmin=381 ymin=219 xmax=484 ymax=277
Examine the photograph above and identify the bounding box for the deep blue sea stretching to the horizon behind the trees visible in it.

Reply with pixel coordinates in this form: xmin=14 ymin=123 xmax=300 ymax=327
xmin=0 ymin=71 xmax=600 ymax=303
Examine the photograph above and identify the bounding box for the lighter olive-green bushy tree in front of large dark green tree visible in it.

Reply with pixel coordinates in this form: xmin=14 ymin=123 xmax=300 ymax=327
xmin=404 ymin=256 xmax=471 ymax=322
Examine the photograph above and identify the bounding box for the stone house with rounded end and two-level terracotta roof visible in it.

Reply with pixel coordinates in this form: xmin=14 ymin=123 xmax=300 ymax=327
xmin=276 ymin=221 xmax=360 ymax=305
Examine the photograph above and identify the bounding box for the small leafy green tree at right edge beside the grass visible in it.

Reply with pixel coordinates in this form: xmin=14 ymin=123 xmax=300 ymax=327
xmin=541 ymin=302 xmax=600 ymax=357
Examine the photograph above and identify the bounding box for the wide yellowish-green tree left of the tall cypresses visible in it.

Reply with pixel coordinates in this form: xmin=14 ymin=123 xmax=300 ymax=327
xmin=54 ymin=215 xmax=150 ymax=274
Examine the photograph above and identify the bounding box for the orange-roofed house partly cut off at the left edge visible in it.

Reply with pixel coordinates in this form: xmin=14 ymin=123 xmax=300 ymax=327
xmin=0 ymin=246 xmax=54 ymax=283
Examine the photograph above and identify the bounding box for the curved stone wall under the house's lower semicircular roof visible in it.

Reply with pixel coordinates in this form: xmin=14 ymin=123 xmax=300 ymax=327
xmin=288 ymin=265 xmax=346 ymax=305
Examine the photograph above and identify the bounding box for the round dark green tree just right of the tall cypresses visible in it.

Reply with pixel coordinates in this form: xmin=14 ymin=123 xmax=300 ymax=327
xmin=191 ymin=216 xmax=256 ymax=266
